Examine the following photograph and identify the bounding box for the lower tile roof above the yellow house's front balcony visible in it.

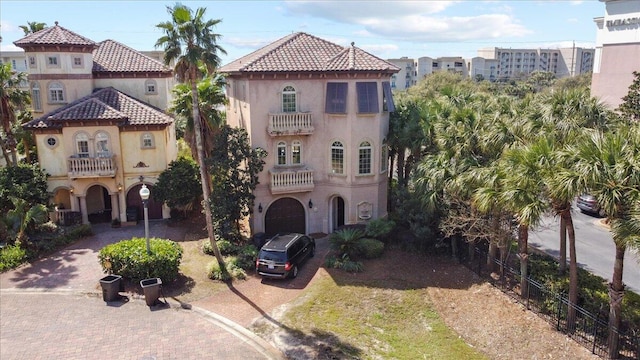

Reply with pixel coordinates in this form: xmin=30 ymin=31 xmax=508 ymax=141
xmin=24 ymin=87 xmax=173 ymax=129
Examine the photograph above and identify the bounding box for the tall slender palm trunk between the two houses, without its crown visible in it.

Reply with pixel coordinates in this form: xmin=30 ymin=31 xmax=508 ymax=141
xmin=190 ymin=76 xmax=226 ymax=271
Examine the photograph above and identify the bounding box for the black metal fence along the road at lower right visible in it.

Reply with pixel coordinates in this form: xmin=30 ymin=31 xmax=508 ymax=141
xmin=462 ymin=248 xmax=640 ymax=360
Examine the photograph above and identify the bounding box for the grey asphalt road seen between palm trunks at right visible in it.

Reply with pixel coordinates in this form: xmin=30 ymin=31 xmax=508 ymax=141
xmin=529 ymin=207 xmax=640 ymax=293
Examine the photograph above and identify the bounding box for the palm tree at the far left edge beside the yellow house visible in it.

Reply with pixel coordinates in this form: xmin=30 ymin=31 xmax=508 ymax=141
xmin=0 ymin=64 xmax=31 ymax=166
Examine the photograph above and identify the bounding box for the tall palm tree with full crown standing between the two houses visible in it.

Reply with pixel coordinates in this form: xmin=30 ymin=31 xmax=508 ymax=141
xmin=156 ymin=3 xmax=226 ymax=269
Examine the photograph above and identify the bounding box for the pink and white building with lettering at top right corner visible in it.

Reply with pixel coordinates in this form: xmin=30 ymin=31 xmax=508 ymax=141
xmin=591 ymin=0 xmax=640 ymax=108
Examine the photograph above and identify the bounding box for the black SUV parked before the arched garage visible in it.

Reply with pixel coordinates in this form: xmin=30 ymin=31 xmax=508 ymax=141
xmin=256 ymin=234 xmax=316 ymax=279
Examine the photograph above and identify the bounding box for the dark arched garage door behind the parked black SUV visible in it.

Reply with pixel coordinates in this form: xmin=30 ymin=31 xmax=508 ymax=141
xmin=264 ymin=198 xmax=305 ymax=236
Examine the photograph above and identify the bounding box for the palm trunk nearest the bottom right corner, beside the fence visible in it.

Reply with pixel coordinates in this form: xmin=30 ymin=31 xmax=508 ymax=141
xmin=609 ymin=242 xmax=627 ymax=359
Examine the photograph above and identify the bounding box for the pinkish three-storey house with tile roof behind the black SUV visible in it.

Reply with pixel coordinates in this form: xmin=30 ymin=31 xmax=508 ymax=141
xmin=219 ymin=32 xmax=400 ymax=235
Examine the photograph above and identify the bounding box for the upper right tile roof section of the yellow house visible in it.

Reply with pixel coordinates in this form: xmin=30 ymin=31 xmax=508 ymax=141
xmin=93 ymin=40 xmax=171 ymax=73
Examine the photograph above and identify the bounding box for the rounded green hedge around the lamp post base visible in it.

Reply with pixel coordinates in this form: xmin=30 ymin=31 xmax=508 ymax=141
xmin=98 ymin=238 xmax=182 ymax=282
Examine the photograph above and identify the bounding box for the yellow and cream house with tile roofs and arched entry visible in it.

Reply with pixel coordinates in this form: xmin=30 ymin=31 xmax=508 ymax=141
xmin=14 ymin=22 xmax=177 ymax=223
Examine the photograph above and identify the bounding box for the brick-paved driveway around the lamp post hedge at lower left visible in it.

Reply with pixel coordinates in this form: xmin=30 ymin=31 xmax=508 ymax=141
xmin=0 ymin=222 xmax=282 ymax=360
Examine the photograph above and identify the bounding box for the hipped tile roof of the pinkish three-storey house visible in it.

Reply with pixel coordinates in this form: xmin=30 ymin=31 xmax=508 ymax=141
xmin=219 ymin=32 xmax=400 ymax=73
